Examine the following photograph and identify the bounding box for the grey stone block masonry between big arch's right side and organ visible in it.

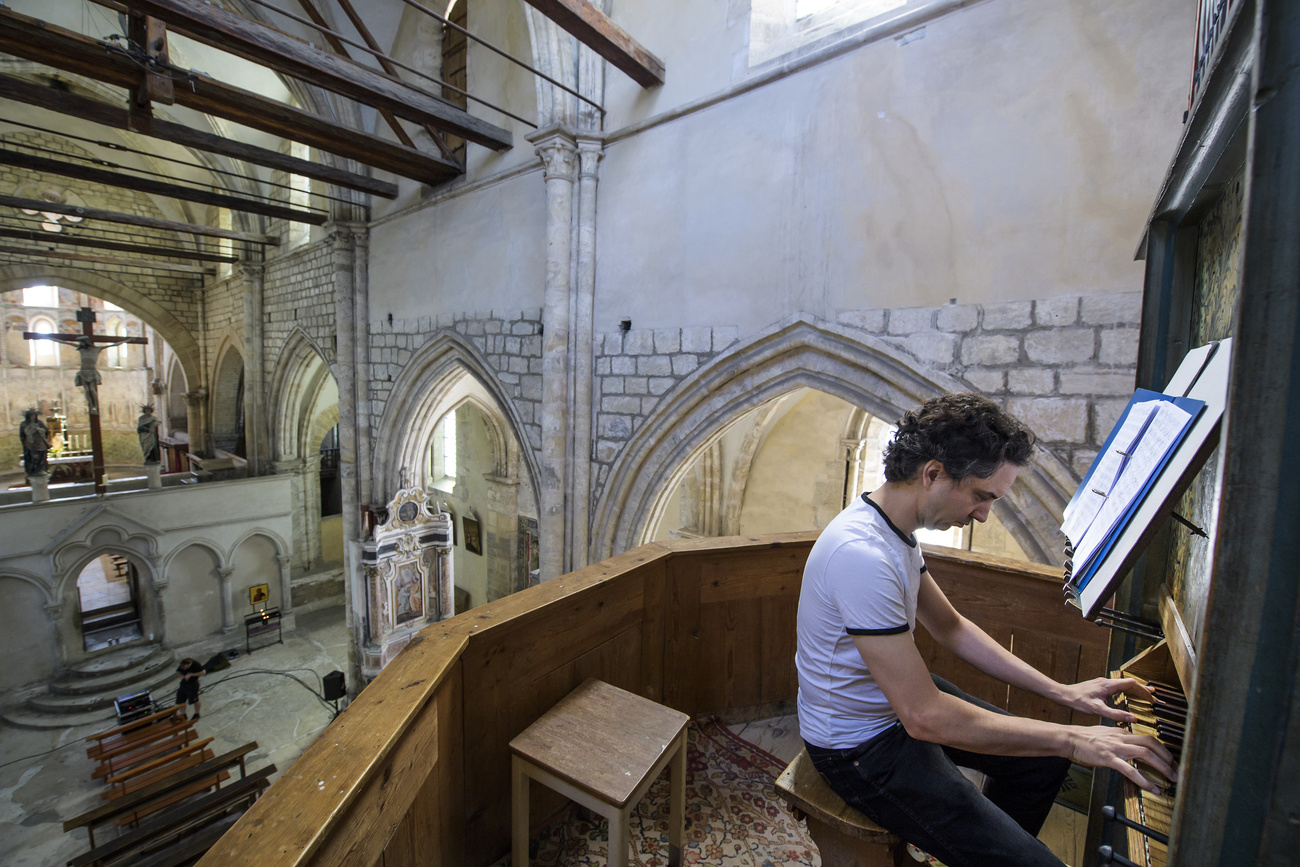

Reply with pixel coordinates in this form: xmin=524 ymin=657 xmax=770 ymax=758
xmin=837 ymin=292 xmax=1141 ymax=476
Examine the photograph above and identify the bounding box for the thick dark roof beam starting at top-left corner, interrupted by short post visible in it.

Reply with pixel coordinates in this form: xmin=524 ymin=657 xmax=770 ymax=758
xmin=0 ymin=6 xmax=462 ymax=183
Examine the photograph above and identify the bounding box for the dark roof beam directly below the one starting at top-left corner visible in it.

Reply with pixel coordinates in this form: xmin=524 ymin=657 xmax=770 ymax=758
xmin=0 ymin=75 xmax=398 ymax=199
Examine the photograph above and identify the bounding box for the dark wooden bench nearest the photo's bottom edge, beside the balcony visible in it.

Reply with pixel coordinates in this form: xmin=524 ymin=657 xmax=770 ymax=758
xmin=68 ymin=764 xmax=276 ymax=867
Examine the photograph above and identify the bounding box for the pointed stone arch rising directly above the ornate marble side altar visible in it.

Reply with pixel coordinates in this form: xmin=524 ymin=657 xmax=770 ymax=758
xmin=374 ymin=329 xmax=540 ymax=502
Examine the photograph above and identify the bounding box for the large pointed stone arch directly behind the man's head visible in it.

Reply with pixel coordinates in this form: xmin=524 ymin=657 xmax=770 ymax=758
xmin=592 ymin=315 xmax=1073 ymax=563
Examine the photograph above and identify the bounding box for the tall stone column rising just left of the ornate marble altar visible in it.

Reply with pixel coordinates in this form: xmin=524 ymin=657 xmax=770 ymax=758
xmin=327 ymin=224 xmax=369 ymax=694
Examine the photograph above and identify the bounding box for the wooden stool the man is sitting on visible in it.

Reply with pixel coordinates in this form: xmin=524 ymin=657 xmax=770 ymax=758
xmin=776 ymin=750 xmax=905 ymax=867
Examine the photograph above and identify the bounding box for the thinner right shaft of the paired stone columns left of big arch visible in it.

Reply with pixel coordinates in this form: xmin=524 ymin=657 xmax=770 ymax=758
xmin=568 ymin=138 xmax=605 ymax=569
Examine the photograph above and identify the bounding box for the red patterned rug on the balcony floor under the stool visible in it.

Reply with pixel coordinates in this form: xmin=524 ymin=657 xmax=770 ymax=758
xmin=494 ymin=718 xmax=822 ymax=867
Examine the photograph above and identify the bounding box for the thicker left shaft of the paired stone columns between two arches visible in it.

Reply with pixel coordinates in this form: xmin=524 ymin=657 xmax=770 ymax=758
xmin=529 ymin=129 xmax=577 ymax=581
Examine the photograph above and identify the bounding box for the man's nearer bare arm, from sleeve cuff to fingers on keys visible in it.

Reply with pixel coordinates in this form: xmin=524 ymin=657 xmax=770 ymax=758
xmin=853 ymin=633 xmax=1178 ymax=790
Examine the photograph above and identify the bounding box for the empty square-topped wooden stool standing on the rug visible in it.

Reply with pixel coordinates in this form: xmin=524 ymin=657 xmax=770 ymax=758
xmin=510 ymin=680 xmax=689 ymax=867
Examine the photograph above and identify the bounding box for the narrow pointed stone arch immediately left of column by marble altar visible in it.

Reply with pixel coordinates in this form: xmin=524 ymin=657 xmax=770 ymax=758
xmin=268 ymin=328 xmax=338 ymax=460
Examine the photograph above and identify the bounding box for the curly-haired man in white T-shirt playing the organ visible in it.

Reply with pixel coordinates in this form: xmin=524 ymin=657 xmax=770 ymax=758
xmin=796 ymin=394 xmax=1178 ymax=867
